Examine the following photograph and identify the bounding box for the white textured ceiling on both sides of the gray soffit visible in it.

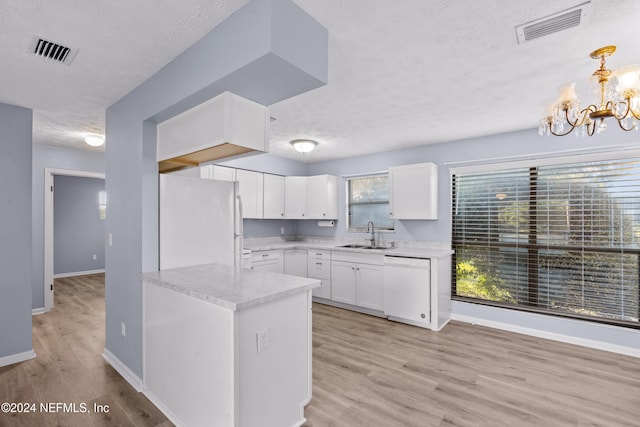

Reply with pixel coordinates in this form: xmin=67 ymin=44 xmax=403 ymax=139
xmin=0 ymin=0 xmax=640 ymax=162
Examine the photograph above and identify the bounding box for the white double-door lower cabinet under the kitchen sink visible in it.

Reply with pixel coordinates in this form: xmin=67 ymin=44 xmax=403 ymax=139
xmin=331 ymin=252 xmax=384 ymax=311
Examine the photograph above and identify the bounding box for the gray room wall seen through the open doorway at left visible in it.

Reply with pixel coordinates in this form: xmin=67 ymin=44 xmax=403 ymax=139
xmin=53 ymin=175 xmax=105 ymax=274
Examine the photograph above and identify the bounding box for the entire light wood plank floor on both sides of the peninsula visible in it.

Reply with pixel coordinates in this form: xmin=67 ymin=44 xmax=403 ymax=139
xmin=0 ymin=275 xmax=640 ymax=427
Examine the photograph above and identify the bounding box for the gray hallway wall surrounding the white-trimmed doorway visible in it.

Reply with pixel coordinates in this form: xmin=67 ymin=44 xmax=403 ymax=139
xmin=31 ymin=144 xmax=105 ymax=308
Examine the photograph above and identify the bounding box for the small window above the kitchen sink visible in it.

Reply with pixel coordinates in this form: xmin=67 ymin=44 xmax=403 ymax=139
xmin=347 ymin=175 xmax=393 ymax=231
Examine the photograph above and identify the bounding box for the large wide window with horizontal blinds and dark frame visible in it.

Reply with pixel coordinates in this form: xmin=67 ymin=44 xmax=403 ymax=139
xmin=452 ymin=159 xmax=640 ymax=327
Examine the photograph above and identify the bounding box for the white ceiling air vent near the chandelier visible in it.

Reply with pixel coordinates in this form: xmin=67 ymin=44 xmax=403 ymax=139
xmin=516 ymin=1 xmax=591 ymax=43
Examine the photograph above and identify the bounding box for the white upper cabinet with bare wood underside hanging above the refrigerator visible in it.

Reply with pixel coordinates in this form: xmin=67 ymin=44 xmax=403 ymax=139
xmin=157 ymin=92 xmax=269 ymax=172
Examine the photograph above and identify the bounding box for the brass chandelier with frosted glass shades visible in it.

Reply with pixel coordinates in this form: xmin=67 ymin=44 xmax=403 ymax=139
xmin=538 ymin=46 xmax=640 ymax=136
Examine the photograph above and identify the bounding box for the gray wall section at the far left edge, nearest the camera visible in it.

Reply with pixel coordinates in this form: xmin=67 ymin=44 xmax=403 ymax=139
xmin=0 ymin=104 xmax=33 ymax=358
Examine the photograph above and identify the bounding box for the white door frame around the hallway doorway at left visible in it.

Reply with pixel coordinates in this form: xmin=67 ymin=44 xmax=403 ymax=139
xmin=42 ymin=168 xmax=105 ymax=312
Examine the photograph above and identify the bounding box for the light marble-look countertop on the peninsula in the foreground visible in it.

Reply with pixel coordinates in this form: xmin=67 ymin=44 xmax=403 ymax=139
xmin=139 ymin=264 xmax=320 ymax=311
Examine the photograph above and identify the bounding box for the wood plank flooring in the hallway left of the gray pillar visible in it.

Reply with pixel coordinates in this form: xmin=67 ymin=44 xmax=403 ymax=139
xmin=0 ymin=274 xmax=173 ymax=427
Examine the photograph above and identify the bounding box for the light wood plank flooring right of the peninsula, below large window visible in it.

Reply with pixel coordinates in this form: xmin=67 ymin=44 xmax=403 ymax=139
xmin=305 ymin=304 xmax=640 ymax=427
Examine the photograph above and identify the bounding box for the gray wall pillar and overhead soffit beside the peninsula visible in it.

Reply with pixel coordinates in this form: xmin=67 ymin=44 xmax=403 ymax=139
xmin=105 ymin=0 xmax=328 ymax=377
